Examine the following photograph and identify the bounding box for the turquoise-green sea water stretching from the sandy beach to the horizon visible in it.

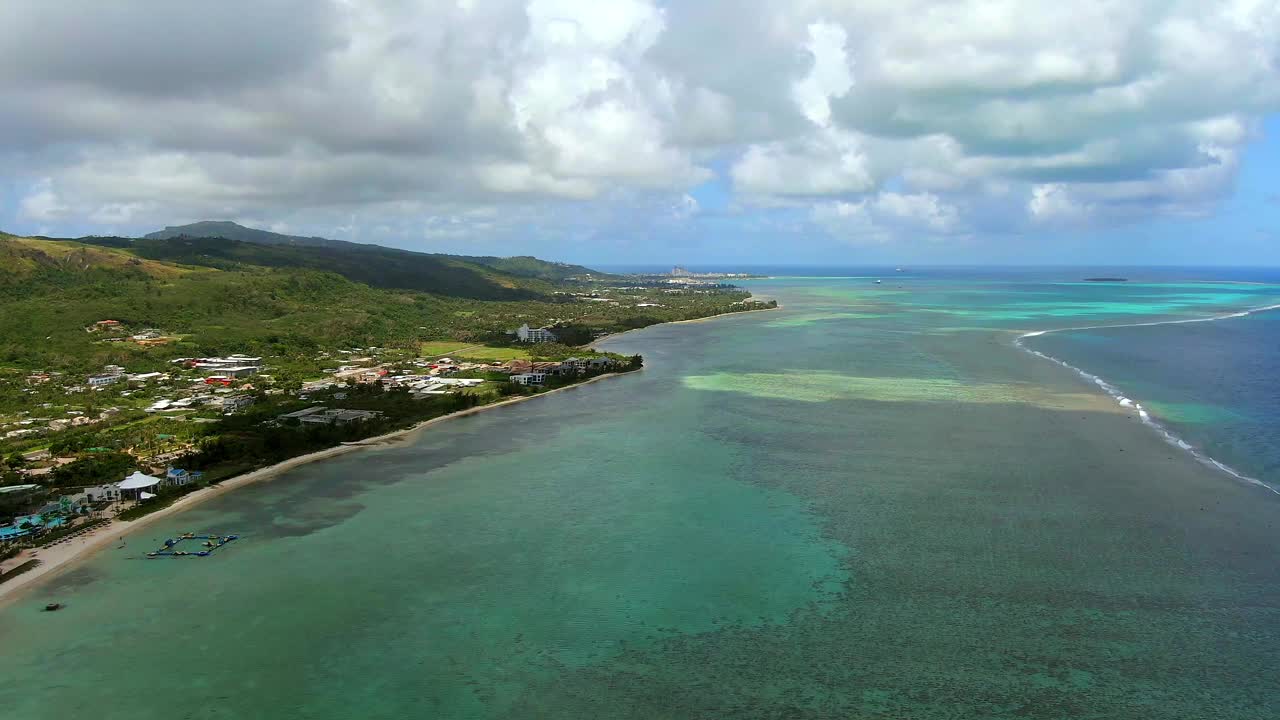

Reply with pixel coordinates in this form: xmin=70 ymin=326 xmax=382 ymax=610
xmin=0 ymin=268 xmax=1280 ymax=720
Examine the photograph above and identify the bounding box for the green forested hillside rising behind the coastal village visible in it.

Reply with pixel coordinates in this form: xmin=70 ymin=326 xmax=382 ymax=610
xmin=0 ymin=228 xmax=746 ymax=372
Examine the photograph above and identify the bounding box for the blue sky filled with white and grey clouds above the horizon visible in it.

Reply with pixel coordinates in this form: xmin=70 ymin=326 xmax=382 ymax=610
xmin=0 ymin=0 xmax=1280 ymax=265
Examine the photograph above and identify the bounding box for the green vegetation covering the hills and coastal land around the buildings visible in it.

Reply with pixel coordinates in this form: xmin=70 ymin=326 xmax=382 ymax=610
xmin=0 ymin=223 xmax=768 ymax=530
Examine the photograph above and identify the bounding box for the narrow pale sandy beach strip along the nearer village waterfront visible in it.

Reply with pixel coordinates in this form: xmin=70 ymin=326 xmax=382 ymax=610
xmin=0 ymin=366 xmax=632 ymax=609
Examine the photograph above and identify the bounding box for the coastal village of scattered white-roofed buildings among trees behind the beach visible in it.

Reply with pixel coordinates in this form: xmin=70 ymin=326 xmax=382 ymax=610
xmin=0 ymin=319 xmax=640 ymax=571
